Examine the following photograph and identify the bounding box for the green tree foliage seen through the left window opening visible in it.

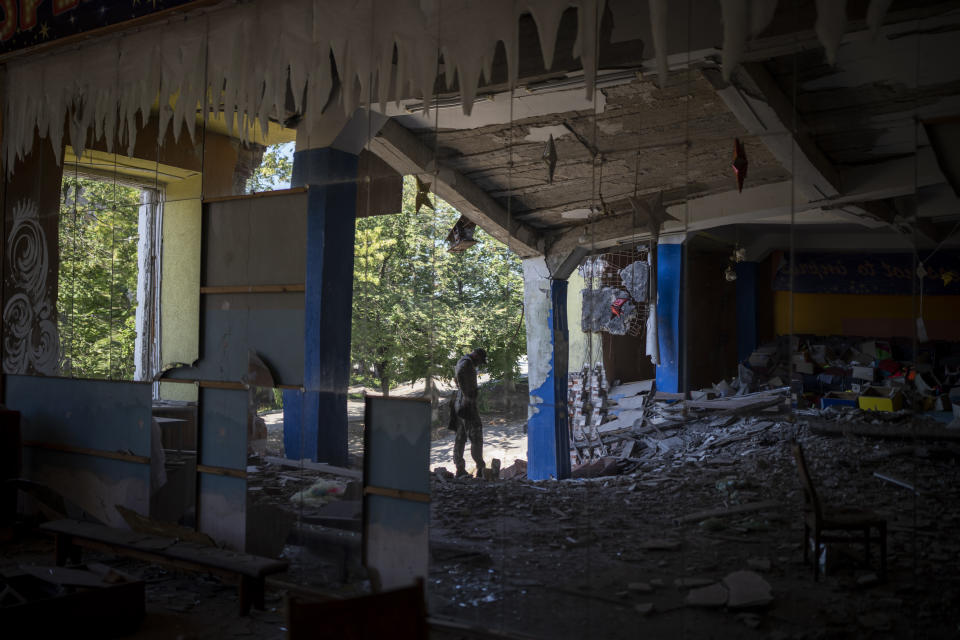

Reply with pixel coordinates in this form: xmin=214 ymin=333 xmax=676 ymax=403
xmin=57 ymin=177 xmax=140 ymax=380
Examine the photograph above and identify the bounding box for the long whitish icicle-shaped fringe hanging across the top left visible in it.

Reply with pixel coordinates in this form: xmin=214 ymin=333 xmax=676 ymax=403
xmin=0 ymin=0 xmax=605 ymax=171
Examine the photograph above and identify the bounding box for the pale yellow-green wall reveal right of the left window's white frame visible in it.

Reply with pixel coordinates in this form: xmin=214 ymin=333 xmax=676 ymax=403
xmin=160 ymin=174 xmax=203 ymax=400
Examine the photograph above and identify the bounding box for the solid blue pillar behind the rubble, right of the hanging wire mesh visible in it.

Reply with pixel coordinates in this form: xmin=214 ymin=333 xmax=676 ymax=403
xmin=657 ymin=242 xmax=683 ymax=393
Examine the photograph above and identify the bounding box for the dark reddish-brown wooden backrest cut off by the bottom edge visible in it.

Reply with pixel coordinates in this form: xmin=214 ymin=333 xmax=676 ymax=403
xmin=287 ymin=580 xmax=428 ymax=640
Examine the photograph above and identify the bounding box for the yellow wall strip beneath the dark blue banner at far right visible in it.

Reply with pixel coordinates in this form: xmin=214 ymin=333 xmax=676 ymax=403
xmin=774 ymin=291 xmax=960 ymax=340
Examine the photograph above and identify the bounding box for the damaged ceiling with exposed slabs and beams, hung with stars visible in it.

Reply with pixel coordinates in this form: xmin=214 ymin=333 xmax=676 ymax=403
xmin=371 ymin=1 xmax=960 ymax=266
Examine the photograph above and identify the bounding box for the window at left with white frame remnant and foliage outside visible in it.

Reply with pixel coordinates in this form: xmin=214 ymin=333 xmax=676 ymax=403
xmin=56 ymin=172 xmax=160 ymax=380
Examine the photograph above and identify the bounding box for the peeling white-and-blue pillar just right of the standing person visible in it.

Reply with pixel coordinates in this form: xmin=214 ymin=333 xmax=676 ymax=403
xmin=523 ymin=258 xmax=570 ymax=480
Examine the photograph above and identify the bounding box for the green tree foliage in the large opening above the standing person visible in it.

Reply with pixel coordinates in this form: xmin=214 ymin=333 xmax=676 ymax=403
xmin=352 ymin=178 xmax=526 ymax=392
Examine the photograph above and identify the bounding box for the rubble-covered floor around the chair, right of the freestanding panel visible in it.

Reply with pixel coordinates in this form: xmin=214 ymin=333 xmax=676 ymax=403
xmin=430 ymin=416 xmax=960 ymax=638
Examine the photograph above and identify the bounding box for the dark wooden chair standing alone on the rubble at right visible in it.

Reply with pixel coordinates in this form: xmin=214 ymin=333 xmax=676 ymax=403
xmin=793 ymin=442 xmax=887 ymax=581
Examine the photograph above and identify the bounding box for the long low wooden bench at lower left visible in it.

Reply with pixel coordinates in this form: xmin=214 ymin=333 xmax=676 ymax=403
xmin=40 ymin=520 xmax=289 ymax=615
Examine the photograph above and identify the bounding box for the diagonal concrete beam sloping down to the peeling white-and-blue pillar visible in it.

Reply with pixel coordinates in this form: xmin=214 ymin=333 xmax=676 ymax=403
xmin=368 ymin=120 xmax=543 ymax=258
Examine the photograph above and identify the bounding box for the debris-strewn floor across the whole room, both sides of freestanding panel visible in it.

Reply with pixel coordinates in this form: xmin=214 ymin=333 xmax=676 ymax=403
xmin=0 ymin=408 xmax=960 ymax=639
